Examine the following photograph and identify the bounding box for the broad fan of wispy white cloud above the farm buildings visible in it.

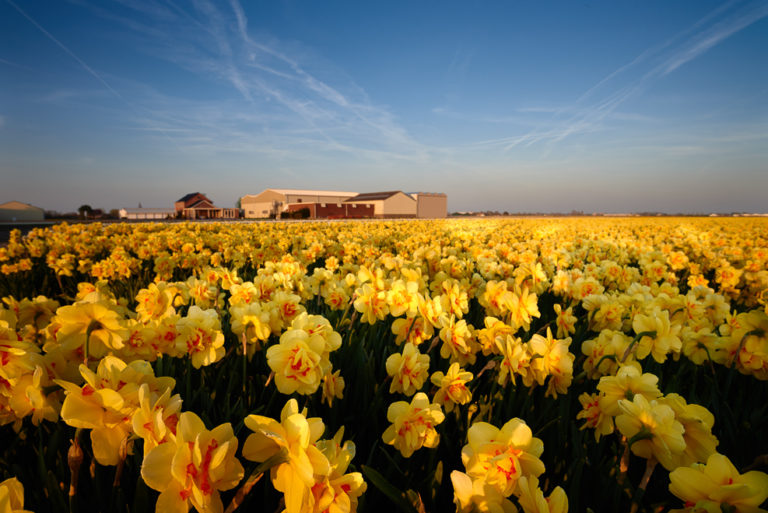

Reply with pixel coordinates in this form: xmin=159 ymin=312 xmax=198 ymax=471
xmin=69 ymin=0 xmax=434 ymax=161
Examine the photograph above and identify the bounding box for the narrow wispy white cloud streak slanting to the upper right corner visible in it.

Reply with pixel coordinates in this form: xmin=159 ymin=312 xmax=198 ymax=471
xmin=480 ymin=0 xmax=768 ymax=151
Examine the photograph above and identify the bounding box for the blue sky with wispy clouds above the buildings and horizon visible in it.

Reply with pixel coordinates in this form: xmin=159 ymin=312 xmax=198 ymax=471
xmin=0 ymin=0 xmax=768 ymax=213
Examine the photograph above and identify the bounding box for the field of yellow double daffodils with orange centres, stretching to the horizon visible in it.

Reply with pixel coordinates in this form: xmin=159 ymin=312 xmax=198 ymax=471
xmin=0 ymin=218 xmax=768 ymax=513
